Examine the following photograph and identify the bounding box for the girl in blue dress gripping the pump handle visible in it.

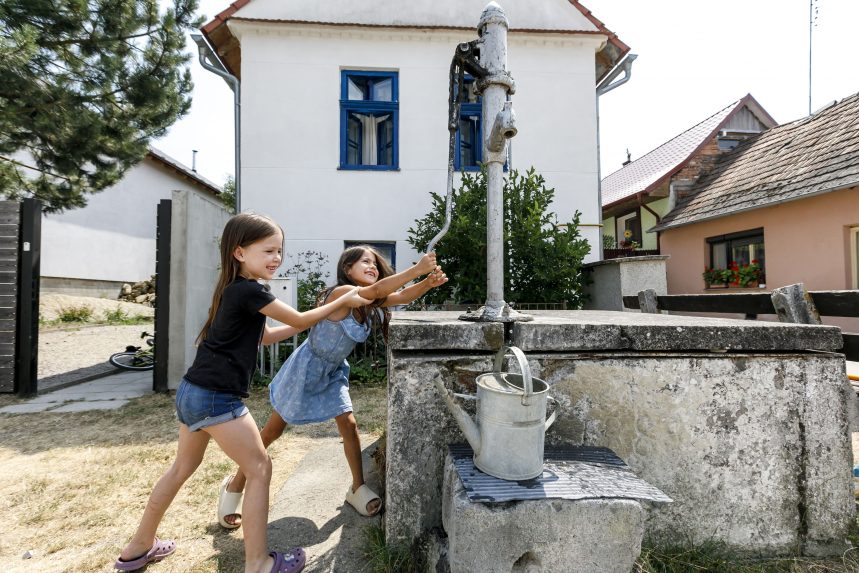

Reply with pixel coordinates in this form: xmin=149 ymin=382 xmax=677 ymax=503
xmin=218 ymin=245 xmax=447 ymax=529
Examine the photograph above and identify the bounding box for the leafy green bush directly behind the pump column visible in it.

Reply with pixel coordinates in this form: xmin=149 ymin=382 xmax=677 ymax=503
xmin=407 ymin=167 xmax=590 ymax=308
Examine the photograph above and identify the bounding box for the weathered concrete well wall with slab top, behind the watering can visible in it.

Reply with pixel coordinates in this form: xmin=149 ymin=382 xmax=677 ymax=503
xmin=386 ymin=311 xmax=854 ymax=555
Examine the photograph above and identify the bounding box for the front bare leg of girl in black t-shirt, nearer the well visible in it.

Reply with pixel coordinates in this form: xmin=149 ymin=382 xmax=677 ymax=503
xmin=204 ymin=414 xmax=274 ymax=573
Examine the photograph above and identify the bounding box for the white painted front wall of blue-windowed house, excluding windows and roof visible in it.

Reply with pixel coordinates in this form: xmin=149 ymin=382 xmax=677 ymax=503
xmin=237 ymin=21 xmax=605 ymax=270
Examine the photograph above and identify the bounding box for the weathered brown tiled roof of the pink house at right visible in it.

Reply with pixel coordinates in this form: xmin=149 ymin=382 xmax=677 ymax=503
xmin=655 ymin=94 xmax=859 ymax=231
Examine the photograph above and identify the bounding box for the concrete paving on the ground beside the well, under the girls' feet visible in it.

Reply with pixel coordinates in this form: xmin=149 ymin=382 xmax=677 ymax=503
xmin=268 ymin=438 xmax=381 ymax=573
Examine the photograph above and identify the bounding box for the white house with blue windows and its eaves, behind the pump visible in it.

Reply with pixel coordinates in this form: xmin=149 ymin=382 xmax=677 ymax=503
xmin=203 ymin=0 xmax=629 ymax=270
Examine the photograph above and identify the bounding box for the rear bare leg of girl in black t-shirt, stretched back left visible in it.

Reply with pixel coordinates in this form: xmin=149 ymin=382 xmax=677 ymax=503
xmin=119 ymin=424 xmax=209 ymax=561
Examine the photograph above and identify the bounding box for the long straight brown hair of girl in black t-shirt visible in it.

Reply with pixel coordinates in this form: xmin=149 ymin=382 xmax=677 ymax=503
xmin=197 ymin=213 xmax=283 ymax=344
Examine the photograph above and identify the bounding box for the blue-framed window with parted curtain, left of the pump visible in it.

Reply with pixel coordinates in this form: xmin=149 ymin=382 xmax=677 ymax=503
xmin=340 ymin=70 xmax=399 ymax=170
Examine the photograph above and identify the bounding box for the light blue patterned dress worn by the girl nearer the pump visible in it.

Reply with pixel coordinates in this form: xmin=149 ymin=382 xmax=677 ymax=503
xmin=269 ymin=312 xmax=370 ymax=424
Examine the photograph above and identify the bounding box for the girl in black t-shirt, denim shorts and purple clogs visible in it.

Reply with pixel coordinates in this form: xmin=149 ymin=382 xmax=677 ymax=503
xmin=114 ymin=213 xmax=370 ymax=573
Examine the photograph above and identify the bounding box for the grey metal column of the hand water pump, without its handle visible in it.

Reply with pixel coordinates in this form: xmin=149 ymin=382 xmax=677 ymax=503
xmin=460 ymin=2 xmax=532 ymax=322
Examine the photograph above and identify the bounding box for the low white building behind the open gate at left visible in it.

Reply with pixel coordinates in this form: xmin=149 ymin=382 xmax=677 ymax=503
xmin=40 ymin=147 xmax=221 ymax=298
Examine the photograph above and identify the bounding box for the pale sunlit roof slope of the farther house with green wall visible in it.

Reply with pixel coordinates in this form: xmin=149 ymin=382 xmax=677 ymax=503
xmin=602 ymin=95 xmax=775 ymax=208
